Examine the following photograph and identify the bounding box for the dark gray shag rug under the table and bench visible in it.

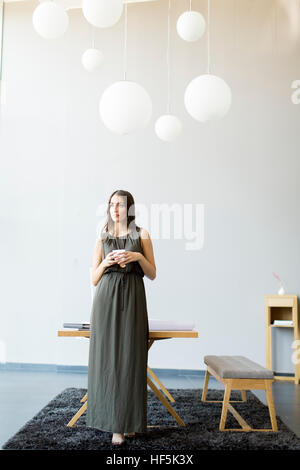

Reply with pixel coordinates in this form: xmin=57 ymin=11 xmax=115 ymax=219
xmin=2 ymin=388 xmax=300 ymax=451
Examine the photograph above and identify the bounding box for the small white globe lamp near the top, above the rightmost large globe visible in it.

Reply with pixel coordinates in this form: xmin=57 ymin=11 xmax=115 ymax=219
xmin=176 ymin=11 xmax=206 ymax=42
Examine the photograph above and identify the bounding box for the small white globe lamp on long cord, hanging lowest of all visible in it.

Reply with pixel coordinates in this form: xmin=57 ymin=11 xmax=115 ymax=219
xmin=154 ymin=0 xmax=182 ymax=142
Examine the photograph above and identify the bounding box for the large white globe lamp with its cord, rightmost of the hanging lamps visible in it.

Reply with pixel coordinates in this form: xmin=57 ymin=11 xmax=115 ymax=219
xmin=184 ymin=0 xmax=232 ymax=122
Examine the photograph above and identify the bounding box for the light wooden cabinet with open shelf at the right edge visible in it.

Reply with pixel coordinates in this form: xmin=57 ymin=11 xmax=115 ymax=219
xmin=265 ymin=295 xmax=300 ymax=384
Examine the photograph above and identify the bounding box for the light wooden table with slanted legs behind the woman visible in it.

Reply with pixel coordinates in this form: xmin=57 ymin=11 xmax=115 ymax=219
xmin=57 ymin=329 xmax=198 ymax=427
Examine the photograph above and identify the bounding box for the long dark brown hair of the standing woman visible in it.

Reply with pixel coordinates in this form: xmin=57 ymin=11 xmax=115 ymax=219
xmin=101 ymin=189 xmax=140 ymax=240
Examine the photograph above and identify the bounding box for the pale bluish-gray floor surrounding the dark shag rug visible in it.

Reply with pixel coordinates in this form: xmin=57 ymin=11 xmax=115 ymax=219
xmin=0 ymin=370 xmax=300 ymax=448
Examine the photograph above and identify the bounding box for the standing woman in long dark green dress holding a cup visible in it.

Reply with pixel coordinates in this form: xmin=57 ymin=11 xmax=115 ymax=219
xmin=87 ymin=190 xmax=156 ymax=444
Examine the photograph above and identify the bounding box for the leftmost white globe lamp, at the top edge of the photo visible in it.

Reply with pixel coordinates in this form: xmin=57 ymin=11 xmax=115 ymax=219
xmin=32 ymin=1 xmax=69 ymax=39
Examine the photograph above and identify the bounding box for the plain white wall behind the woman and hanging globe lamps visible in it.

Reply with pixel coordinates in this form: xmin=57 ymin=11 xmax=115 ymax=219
xmin=0 ymin=0 xmax=300 ymax=371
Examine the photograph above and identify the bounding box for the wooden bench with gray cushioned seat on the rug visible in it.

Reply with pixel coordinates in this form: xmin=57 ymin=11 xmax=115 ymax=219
xmin=202 ymin=356 xmax=278 ymax=432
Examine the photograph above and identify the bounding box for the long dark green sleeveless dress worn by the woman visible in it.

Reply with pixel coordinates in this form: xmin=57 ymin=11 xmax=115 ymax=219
xmin=86 ymin=227 xmax=149 ymax=433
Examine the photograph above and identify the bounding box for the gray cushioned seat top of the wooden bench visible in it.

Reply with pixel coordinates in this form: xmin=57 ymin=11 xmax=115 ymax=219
xmin=204 ymin=356 xmax=274 ymax=379
